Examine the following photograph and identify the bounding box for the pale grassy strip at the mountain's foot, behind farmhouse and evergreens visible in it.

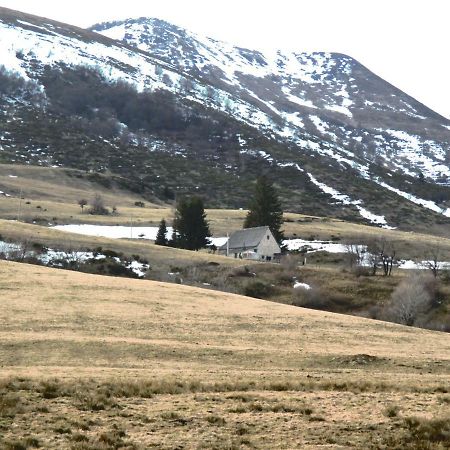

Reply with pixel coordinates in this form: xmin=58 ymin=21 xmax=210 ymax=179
xmin=0 ymin=165 xmax=450 ymax=260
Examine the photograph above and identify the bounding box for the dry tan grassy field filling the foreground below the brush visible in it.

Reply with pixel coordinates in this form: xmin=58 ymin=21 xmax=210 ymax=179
xmin=0 ymin=262 xmax=450 ymax=449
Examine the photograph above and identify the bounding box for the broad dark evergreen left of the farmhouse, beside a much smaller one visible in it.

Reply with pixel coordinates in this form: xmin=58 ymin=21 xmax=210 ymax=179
xmin=173 ymin=197 xmax=211 ymax=250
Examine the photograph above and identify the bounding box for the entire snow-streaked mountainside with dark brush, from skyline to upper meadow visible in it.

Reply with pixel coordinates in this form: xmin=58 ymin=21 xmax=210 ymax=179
xmin=0 ymin=8 xmax=450 ymax=234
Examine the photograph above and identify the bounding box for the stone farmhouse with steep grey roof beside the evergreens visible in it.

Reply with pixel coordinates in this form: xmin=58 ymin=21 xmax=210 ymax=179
xmin=219 ymin=227 xmax=281 ymax=261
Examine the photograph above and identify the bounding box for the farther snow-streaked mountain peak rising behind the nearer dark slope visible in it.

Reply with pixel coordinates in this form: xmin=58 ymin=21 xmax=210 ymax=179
xmin=91 ymin=18 xmax=450 ymax=183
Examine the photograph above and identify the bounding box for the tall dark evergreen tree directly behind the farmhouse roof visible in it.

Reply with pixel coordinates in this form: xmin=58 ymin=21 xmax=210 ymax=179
xmin=244 ymin=175 xmax=283 ymax=243
